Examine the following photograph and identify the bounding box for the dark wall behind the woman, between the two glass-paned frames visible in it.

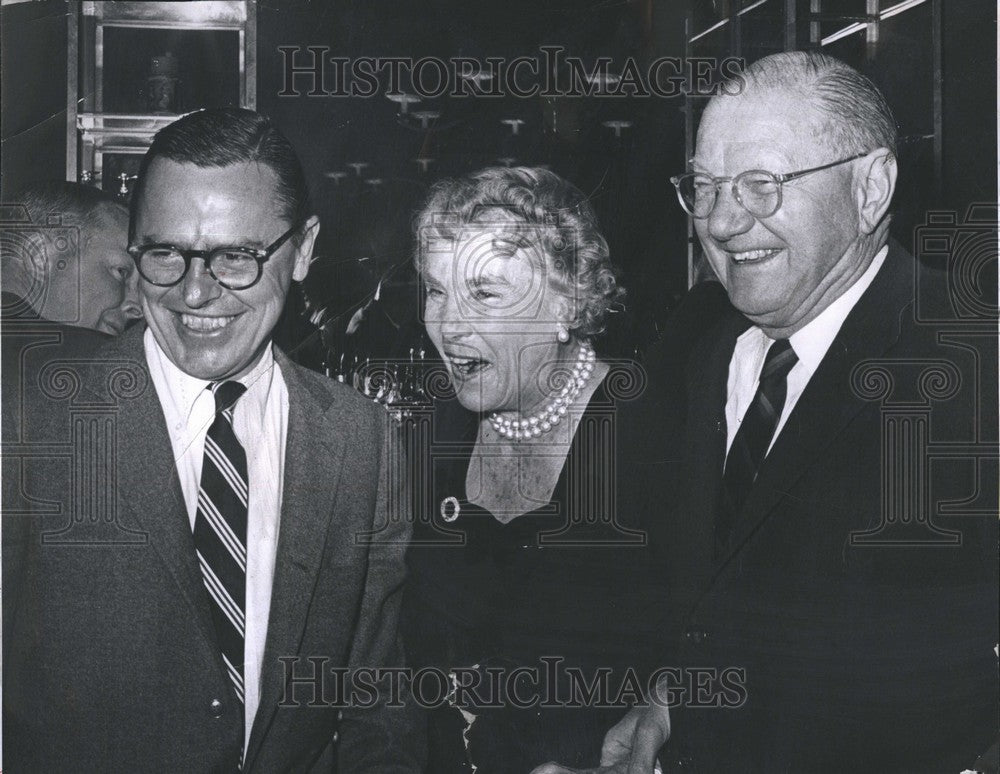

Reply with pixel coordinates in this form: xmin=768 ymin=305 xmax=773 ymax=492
xmin=258 ymin=0 xmax=687 ymax=354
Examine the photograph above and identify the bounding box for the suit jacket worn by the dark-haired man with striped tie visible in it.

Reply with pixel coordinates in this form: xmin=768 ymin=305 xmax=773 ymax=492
xmin=3 ymin=326 xmax=422 ymax=774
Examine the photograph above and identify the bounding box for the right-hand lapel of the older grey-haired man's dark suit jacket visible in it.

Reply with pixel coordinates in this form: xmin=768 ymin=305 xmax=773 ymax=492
xmin=716 ymin=244 xmax=914 ymax=572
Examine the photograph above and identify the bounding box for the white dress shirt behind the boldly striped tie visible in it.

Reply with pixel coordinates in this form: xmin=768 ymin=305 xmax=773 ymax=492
xmin=143 ymin=329 xmax=288 ymax=750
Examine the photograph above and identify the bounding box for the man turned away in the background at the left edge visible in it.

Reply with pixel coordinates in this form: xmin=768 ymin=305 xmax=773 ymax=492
xmin=0 ymin=182 xmax=142 ymax=441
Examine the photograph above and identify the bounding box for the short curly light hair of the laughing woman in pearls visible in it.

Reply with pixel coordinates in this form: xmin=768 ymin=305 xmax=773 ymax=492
xmin=415 ymin=167 xmax=625 ymax=336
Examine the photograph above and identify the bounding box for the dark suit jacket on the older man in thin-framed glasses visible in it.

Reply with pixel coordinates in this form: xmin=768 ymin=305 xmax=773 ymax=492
xmin=647 ymin=246 xmax=998 ymax=772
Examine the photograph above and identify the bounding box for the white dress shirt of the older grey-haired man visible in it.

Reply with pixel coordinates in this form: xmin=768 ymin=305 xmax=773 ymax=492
xmin=726 ymin=245 xmax=889 ymax=455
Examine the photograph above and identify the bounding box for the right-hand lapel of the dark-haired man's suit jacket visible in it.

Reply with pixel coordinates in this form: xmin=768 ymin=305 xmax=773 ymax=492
xmin=246 ymin=356 xmax=350 ymax=768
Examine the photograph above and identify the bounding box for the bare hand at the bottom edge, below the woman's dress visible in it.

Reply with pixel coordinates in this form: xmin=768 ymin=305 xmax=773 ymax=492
xmin=531 ymin=704 xmax=670 ymax=774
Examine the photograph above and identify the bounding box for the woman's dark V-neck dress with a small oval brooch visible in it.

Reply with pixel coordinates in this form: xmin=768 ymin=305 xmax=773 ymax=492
xmin=402 ymin=377 xmax=666 ymax=774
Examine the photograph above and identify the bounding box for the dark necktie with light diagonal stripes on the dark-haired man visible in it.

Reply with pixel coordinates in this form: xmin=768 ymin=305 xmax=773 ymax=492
xmin=194 ymin=382 xmax=249 ymax=719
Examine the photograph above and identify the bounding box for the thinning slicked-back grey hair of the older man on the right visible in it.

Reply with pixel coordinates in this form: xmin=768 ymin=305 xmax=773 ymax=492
xmin=741 ymin=51 xmax=897 ymax=154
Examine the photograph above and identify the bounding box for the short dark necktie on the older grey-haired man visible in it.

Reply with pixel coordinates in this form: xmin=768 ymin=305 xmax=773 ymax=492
xmin=715 ymin=339 xmax=798 ymax=549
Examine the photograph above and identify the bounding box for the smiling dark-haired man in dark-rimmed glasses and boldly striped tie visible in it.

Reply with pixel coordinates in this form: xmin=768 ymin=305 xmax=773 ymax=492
xmin=3 ymin=109 xmax=421 ymax=774
